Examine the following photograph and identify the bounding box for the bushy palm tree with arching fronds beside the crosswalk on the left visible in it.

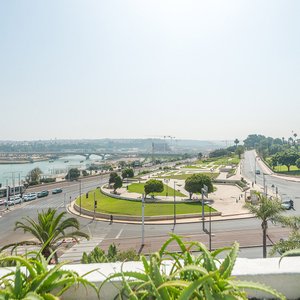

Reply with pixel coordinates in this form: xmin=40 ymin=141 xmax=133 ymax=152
xmin=0 ymin=208 xmax=89 ymax=263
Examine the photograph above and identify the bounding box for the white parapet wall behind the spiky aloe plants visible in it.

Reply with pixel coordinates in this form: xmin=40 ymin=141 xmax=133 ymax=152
xmin=0 ymin=257 xmax=300 ymax=300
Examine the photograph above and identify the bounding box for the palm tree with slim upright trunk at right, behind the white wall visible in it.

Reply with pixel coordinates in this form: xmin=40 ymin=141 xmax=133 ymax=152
xmin=245 ymin=193 xmax=284 ymax=258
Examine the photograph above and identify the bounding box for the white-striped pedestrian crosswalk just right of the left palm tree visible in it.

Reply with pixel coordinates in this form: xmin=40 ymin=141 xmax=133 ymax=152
xmin=59 ymin=234 xmax=106 ymax=263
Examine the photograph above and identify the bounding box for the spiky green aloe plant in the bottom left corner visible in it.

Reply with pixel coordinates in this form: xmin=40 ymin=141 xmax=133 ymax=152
xmin=0 ymin=252 xmax=98 ymax=300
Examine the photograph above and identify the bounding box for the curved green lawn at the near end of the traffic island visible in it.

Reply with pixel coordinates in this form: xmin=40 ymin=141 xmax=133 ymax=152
xmin=76 ymin=189 xmax=216 ymax=216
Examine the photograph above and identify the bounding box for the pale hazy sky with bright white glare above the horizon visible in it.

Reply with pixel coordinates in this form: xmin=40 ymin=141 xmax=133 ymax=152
xmin=0 ymin=0 xmax=300 ymax=140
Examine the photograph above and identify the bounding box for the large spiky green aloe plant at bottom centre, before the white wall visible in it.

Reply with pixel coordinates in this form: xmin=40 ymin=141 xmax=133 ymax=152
xmin=100 ymin=235 xmax=285 ymax=300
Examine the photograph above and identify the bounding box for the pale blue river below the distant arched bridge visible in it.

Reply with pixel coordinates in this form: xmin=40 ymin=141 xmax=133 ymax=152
xmin=0 ymin=155 xmax=102 ymax=186
